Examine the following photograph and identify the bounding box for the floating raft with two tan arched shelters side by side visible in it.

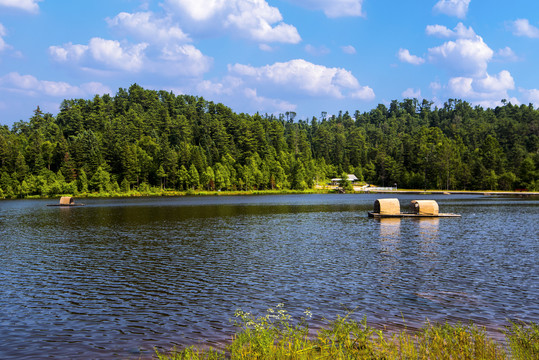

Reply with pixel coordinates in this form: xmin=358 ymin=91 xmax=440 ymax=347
xmin=369 ymin=199 xmax=460 ymax=218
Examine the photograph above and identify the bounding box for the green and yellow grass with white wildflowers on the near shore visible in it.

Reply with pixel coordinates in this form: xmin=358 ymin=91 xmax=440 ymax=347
xmin=156 ymin=305 xmax=539 ymax=360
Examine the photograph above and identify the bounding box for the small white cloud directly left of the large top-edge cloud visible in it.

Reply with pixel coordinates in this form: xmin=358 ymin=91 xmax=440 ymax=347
xmin=107 ymin=12 xmax=190 ymax=43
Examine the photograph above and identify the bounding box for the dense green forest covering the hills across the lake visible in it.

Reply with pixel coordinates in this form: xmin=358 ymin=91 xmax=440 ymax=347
xmin=0 ymin=84 xmax=539 ymax=198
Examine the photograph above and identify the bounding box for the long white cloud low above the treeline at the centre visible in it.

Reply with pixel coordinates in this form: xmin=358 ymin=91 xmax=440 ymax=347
xmin=229 ymin=59 xmax=374 ymax=100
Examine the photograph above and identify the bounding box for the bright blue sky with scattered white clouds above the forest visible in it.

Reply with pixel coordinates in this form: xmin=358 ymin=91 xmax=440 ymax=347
xmin=0 ymin=0 xmax=539 ymax=126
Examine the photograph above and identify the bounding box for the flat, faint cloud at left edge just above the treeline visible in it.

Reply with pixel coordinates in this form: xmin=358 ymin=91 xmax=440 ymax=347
xmin=0 ymin=72 xmax=112 ymax=98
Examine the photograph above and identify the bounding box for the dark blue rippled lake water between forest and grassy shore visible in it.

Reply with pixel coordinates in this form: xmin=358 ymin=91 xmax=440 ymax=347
xmin=0 ymin=195 xmax=539 ymax=359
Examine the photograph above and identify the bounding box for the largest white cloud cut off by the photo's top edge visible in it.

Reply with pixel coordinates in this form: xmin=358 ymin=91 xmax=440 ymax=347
xmin=165 ymin=0 xmax=301 ymax=44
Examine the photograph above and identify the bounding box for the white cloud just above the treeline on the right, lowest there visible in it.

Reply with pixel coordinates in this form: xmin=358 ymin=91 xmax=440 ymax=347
xmin=448 ymin=70 xmax=515 ymax=107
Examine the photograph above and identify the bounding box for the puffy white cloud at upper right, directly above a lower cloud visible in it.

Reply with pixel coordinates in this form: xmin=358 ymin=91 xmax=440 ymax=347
xmin=428 ymin=36 xmax=494 ymax=77
